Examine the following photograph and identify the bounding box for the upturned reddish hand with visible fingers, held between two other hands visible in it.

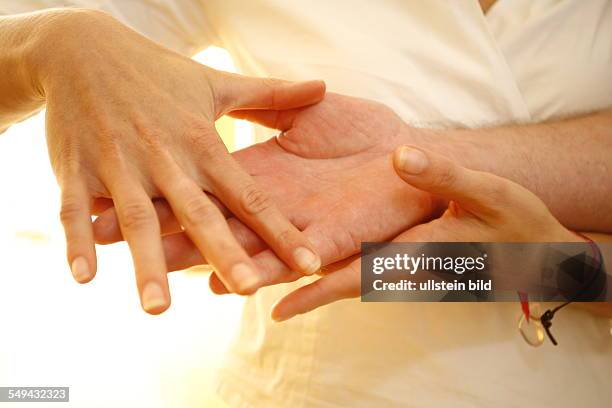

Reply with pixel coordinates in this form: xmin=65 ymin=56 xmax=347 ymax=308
xmin=94 ymin=94 xmax=443 ymax=293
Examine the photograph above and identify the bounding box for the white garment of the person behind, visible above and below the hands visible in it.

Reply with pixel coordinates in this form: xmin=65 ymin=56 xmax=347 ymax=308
xmin=0 ymin=0 xmax=612 ymax=407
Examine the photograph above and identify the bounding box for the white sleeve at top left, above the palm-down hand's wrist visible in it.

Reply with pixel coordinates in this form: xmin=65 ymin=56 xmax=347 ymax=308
xmin=0 ymin=0 xmax=216 ymax=56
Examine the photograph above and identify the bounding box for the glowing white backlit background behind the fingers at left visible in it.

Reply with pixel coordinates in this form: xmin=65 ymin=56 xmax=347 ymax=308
xmin=0 ymin=47 xmax=253 ymax=408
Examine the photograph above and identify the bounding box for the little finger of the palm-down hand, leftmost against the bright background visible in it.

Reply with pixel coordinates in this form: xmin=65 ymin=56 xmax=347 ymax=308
xmin=60 ymin=177 xmax=96 ymax=283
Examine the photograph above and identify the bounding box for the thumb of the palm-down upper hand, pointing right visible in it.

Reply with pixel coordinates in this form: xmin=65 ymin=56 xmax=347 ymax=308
xmin=212 ymin=72 xmax=325 ymax=116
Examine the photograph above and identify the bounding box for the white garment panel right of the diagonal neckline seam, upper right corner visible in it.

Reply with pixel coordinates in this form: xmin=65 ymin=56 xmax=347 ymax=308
xmin=487 ymin=0 xmax=612 ymax=121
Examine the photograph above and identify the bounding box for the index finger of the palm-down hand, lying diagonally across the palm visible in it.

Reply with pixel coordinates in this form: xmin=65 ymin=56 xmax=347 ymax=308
xmin=207 ymin=148 xmax=321 ymax=275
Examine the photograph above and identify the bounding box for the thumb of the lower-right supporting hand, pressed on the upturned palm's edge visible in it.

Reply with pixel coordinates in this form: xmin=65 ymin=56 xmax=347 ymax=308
xmin=393 ymin=146 xmax=512 ymax=216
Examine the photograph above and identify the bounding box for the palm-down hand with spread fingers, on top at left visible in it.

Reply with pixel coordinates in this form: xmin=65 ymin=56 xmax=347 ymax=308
xmin=38 ymin=10 xmax=325 ymax=313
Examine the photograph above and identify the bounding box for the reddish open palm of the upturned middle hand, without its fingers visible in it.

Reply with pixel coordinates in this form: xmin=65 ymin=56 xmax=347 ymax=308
xmin=234 ymin=94 xmax=429 ymax=262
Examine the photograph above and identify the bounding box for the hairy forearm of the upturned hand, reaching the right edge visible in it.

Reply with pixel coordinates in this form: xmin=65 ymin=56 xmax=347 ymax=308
xmin=425 ymin=111 xmax=612 ymax=233
